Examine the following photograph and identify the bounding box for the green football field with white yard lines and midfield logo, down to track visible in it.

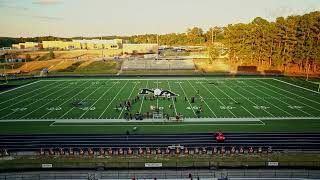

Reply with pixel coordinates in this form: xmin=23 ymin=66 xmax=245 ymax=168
xmin=0 ymin=78 xmax=320 ymax=133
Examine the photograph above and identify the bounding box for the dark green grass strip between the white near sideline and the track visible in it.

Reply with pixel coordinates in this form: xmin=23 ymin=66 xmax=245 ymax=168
xmin=0 ymin=119 xmax=320 ymax=134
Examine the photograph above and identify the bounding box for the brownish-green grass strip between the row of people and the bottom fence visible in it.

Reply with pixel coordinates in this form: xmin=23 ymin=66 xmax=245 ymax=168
xmin=0 ymin=153 xmax=320 ymax=169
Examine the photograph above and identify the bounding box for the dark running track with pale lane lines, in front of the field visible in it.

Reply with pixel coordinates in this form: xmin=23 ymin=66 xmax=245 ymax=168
xmin=0 ymin=133 xmax=320 ymax=151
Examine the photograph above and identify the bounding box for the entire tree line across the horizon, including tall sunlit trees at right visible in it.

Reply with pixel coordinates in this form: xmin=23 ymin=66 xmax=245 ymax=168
xmin=0 ymin=11 xmax=320 ymax=71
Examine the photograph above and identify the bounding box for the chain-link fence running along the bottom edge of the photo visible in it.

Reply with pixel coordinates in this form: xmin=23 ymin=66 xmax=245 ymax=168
xmin=0 ymin=169 xmax=320 ymax=180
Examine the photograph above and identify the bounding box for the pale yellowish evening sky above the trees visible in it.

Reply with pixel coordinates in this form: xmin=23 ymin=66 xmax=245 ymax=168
xmin=0 ymin=0 xmax=320 ymax=37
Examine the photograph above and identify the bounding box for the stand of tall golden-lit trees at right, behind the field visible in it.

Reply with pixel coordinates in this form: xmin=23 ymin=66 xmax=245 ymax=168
xmin=223 ymin=11 xmax=320 ymax=71
